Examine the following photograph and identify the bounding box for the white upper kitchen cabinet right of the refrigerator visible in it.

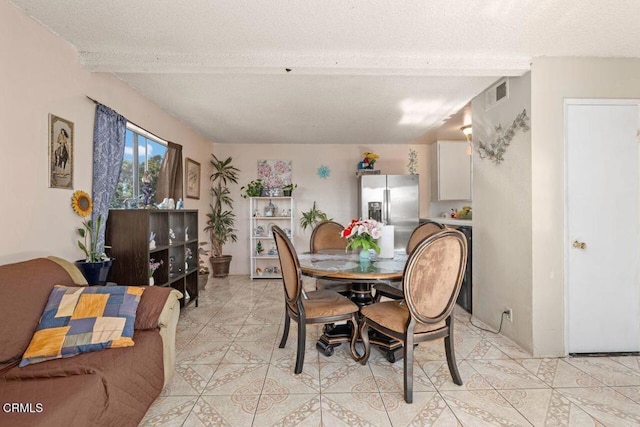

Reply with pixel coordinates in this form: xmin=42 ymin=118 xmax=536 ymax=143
xmin=431 ymin=141 xmax=471 ymax=201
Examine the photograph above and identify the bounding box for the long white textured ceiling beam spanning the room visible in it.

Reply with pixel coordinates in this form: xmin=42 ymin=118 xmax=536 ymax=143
xmin=79 ymin=52 xmax=531 ymax=77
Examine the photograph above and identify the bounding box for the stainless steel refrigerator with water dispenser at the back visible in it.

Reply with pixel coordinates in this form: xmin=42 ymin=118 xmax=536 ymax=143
xmin=358 ymin=175 xmax=420 ymax=250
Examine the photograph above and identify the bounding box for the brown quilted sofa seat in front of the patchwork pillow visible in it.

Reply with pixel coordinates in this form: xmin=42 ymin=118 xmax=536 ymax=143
xmin=0 ymin=330 xmax=164 ymax=427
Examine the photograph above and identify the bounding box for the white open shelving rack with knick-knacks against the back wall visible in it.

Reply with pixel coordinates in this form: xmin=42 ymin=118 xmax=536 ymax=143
xmin=249 ymin=197 xmax=295 ymax=280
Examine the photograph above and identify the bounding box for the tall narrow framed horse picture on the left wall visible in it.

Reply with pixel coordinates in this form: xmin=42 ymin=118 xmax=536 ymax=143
xmin=49 ymin=114 xmax=74 ymax=190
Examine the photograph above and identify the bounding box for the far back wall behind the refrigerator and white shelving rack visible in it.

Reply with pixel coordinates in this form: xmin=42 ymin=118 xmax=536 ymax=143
xmin=214 ymin=144 xmax=431 ymax=274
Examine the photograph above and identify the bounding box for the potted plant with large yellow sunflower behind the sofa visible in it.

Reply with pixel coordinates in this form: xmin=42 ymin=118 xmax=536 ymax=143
xmin=71 ymin=190 xmax=113 ymax=285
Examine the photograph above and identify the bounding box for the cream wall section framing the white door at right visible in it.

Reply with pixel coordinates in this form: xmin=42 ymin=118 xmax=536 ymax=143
xmin=528 ymin=58 xmax=640 ymax=356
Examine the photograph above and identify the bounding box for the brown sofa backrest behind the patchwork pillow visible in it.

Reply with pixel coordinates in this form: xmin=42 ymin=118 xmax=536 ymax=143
xmin=0 ymin=258 xmax=73 ymax=363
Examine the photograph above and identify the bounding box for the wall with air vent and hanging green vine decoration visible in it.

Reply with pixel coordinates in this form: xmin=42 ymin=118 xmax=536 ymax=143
xmin=472 ymin=73 xmax=533 ymax=350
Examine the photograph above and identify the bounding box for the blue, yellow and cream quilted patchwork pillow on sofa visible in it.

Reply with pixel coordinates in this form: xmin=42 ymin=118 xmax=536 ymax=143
xmin=20 ymin=286 xmax=144 ymax=366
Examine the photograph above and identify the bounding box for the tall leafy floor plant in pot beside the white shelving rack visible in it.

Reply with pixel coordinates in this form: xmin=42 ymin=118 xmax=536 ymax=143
xmin=204 ymin=154 xmax=240 ymax=277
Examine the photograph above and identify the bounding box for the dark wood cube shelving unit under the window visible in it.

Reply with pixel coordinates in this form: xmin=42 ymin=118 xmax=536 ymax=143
xmin=105 ymin=209 xmax=198 ymax=307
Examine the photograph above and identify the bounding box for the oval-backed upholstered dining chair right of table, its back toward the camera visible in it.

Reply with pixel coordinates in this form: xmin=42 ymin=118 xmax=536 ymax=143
xmin=359 ymin=229 xmax=467 ymax=403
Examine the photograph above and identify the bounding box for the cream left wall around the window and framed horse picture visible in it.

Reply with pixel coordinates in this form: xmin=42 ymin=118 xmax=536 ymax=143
xmin=0 ymin=1 xmax=213 ymax=264
